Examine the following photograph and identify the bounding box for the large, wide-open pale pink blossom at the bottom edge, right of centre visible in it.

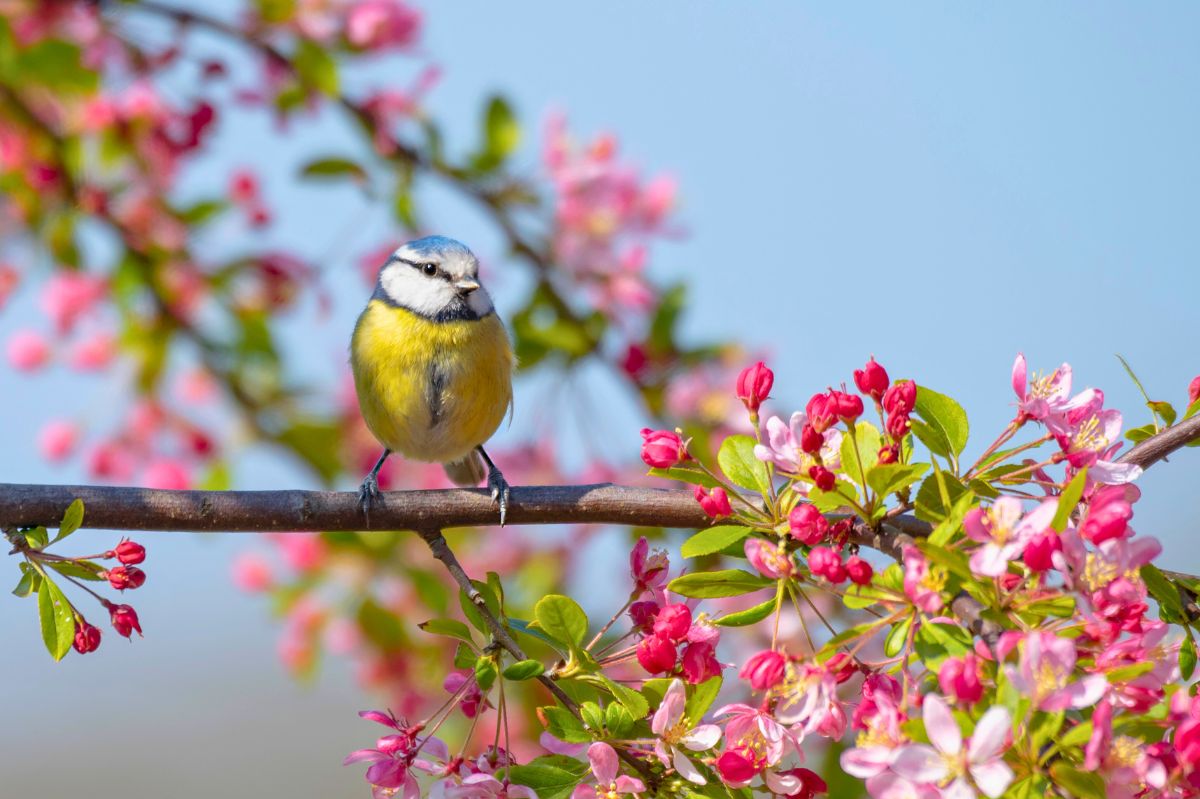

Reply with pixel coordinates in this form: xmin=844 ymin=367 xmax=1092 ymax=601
xmin=892 ymin=693 xmax=1013 ymax=799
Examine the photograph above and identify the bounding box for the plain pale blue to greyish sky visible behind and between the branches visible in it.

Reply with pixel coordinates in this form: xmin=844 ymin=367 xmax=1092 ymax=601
xmin=0 ymin=2 xmax=1200 ymax=799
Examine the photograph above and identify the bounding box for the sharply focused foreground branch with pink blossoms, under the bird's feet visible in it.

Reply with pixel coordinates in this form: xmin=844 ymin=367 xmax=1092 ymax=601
xmin=7 ymin=358 xmax=1200 ymax=799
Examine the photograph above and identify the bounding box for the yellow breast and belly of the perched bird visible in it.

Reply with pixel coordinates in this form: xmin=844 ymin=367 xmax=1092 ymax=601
xmin=350 ymin=300 xmax=514 ymax=463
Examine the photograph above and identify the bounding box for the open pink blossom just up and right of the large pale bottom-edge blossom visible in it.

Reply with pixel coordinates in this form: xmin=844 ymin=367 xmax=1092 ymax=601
xmin=1010 ymin=632 xmax=1108 ymax=713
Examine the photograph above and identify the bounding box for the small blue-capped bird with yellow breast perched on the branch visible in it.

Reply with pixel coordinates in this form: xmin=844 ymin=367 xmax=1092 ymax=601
xmin=350 ymin=236 xmax=514 ymax=524
